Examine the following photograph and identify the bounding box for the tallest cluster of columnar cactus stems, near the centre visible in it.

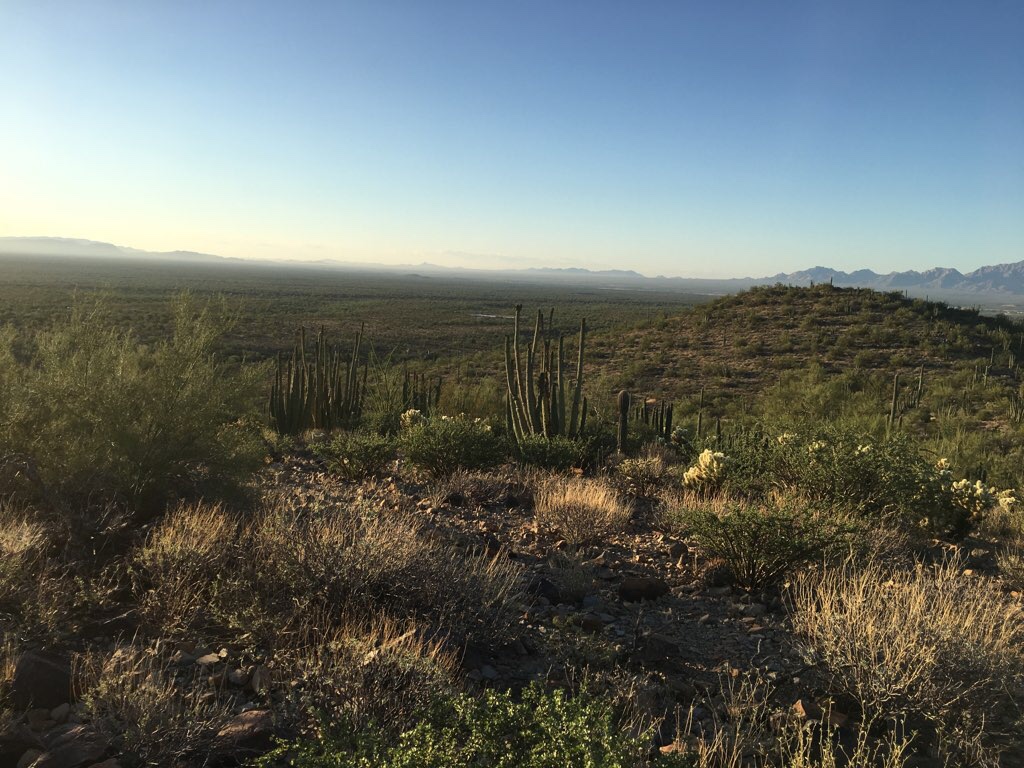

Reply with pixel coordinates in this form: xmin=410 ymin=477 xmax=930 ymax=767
xmin=505 ymin=304 xmax=587 ymax=444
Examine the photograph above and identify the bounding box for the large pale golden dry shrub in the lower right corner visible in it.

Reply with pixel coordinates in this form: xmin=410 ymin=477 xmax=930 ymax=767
xmin=793 ymin=561 xmax=1024 ymax=761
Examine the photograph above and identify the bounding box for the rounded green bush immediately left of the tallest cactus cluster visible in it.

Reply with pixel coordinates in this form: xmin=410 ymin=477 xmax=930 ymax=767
xmin=399 ymin=416 xmax=505 ymax=476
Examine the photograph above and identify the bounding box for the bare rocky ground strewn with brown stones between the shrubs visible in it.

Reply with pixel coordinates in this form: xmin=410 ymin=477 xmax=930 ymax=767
xmin=0 ymin=455 xmax=1024 ymax=768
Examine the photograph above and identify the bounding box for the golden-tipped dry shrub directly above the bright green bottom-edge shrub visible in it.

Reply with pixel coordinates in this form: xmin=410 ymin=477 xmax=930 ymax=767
xmin=274 ymin=614 xmax=458 ymax=728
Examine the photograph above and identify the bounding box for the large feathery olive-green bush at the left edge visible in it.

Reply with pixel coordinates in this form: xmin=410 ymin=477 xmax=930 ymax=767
xmin=0 ymin=298 xmax=260 ymax=512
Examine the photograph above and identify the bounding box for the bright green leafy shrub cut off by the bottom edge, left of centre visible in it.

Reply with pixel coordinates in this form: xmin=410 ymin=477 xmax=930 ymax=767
xmin=258 ymin=684 xmax=648 ymax=768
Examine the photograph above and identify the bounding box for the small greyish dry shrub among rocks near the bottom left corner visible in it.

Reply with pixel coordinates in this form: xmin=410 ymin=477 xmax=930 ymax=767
xmin=75 ymin=646 xmax=231 ymax=765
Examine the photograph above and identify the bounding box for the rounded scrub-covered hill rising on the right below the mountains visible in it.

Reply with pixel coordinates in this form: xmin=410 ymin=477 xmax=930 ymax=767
xmin=593 ymin=284 xmax=1024 ymax=398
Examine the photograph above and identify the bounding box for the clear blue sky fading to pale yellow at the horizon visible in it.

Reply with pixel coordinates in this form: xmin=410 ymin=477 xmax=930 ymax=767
xmin=0 ymin=0 xmax=1024 ymax=276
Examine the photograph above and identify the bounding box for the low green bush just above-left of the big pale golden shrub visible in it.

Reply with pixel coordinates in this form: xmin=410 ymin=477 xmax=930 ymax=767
xmin=669 ymin=496 xmax=857 ymax=590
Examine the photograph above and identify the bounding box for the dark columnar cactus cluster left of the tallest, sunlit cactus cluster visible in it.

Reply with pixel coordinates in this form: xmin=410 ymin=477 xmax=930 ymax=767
xmin=270 ymin=328 xmax=367 ymax=434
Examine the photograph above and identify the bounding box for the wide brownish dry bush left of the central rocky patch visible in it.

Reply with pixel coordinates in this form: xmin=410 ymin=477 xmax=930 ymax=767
xmin=210 ymin=501 xmax=519 ymax=645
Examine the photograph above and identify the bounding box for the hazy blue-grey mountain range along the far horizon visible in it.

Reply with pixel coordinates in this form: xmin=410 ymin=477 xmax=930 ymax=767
xmin=0 ymin=238 xmax=1024 ymax=297
